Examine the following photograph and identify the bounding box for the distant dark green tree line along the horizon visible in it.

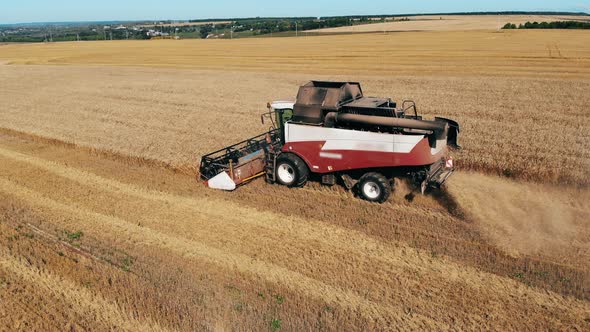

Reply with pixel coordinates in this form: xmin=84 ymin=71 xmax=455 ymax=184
xmin=0 ymin=12 xmax=590 ymax=42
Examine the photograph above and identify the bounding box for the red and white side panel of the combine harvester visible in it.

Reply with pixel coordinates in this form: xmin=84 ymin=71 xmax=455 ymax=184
xmin=282 ymin=122 xmax=446 ymax=173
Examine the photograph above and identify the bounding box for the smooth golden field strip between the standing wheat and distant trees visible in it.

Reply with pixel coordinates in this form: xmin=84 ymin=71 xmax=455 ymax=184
xmin=0 ymin=30 xmax=590 ymax=79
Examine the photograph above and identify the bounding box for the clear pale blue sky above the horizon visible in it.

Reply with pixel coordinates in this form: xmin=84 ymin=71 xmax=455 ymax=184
xmin=0 ymin=0 xmax=590 ymax=24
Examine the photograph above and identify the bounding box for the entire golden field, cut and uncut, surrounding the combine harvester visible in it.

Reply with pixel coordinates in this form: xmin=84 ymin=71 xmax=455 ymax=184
xmin=0 ymin=27 xmax=590 ymax=331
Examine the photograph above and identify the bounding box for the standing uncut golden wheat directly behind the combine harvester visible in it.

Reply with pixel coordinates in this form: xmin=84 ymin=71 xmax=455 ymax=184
xmin=0 ymin=61 xmax=590 ymax=186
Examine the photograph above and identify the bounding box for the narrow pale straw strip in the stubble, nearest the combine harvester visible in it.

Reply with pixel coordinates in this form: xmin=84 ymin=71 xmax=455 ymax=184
xmin=0 ymin=144 xmax=472 ymax=278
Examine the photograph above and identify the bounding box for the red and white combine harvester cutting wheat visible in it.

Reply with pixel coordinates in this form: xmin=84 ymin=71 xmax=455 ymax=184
xmin=199 ymin=81 xmax=459 ymax=203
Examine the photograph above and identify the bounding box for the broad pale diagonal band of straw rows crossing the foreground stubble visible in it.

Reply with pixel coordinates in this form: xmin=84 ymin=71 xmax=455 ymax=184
xmin=0 ymin=132 xmax=589 ymax=329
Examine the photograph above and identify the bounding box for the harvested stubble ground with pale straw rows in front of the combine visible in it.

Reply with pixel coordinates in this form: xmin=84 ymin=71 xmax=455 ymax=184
xmin=0 ymin=135 xmax=588 ymax=330
